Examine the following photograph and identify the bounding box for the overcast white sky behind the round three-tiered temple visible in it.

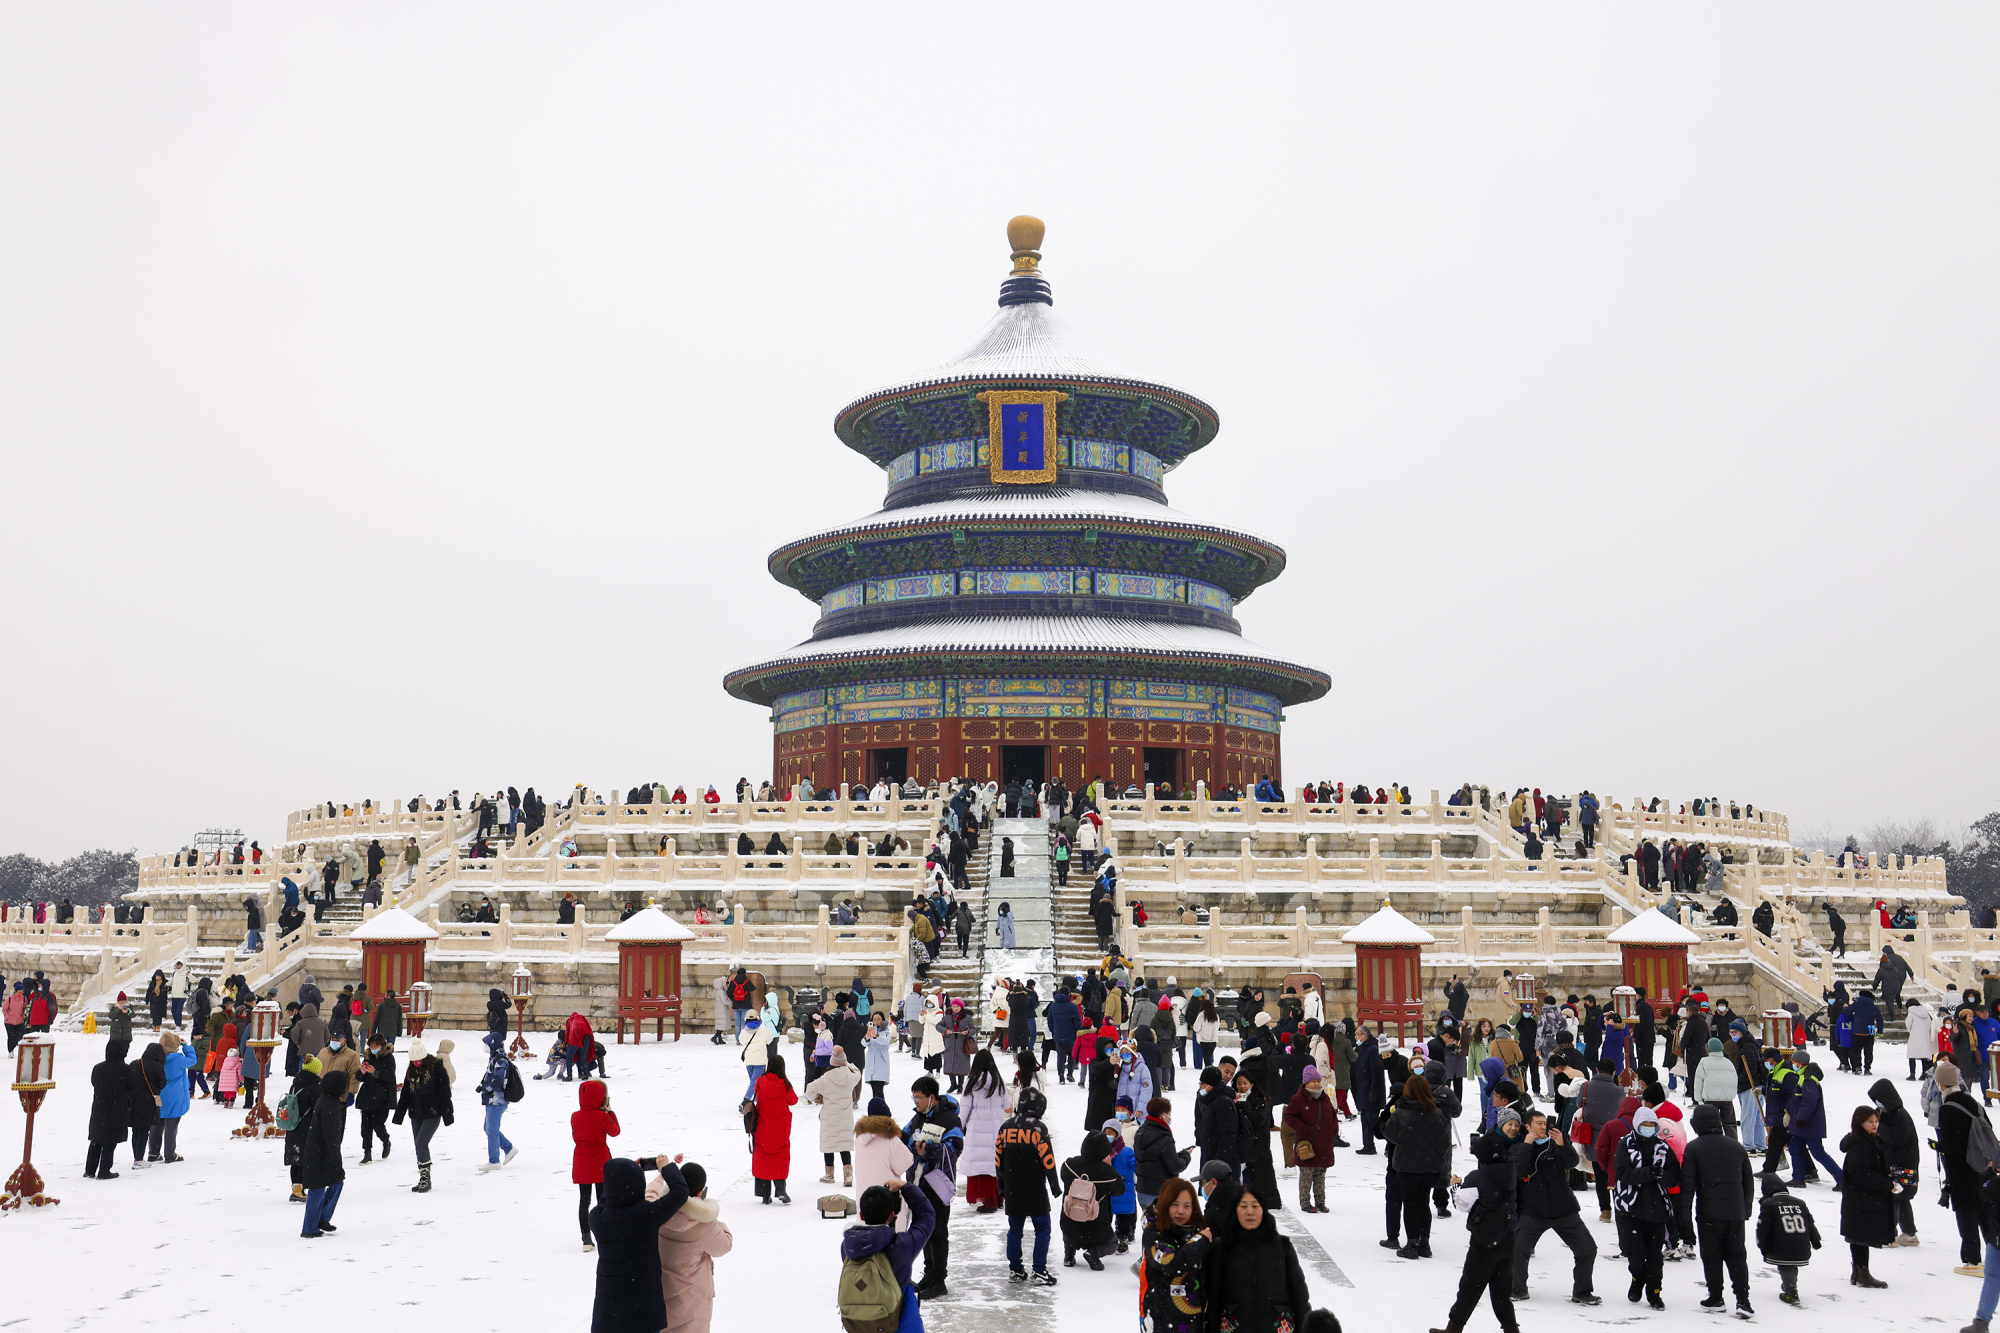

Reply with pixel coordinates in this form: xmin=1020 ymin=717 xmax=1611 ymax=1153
xmin=0 ymin=4 xmax=2000 ymax=857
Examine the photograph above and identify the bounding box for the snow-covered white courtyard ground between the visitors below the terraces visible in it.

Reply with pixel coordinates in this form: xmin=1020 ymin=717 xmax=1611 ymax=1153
xmin=0 ymin=1029 xmax=1980 ymax=1333
